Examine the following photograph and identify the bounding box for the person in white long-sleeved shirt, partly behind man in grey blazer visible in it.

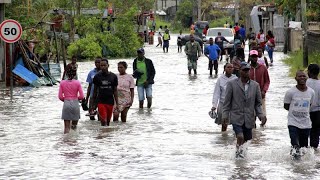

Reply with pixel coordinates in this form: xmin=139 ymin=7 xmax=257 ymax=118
xmin=211 ymin=63 xmax=237 ymax=131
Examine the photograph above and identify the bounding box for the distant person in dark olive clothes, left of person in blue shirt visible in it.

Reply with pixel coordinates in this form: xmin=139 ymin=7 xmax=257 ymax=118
xmin=184 ymin=34 xmax=202 ymax=75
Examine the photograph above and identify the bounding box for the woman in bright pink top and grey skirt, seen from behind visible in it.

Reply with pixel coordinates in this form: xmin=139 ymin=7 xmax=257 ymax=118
xmin=59 ymin=69 xmax=84 ymax=134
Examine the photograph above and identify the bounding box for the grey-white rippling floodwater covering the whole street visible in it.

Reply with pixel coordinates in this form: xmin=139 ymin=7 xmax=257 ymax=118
xmin=0 ymin=35 xmax=320 ymax=179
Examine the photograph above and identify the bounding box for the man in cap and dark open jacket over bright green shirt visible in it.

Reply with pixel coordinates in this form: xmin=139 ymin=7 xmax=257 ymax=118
xmin=133 ymin=48 xmax=156 ymax=108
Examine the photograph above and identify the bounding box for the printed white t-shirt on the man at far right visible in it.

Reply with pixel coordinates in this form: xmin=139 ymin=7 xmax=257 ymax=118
xmin=284 ymin=86 xmax=314 ymax=129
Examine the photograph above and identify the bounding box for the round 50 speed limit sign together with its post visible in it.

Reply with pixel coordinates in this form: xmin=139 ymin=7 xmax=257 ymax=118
xmin=0 ymin=19 xmax=22 ymax=101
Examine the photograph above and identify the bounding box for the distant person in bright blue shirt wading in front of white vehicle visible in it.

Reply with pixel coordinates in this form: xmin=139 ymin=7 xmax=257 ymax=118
xmin=204 ymin=38 xmax=221 ymax=78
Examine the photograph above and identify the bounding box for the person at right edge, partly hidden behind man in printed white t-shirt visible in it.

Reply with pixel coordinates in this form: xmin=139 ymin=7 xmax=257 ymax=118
xmin=307 ymin=64 xmax=320 ymax=150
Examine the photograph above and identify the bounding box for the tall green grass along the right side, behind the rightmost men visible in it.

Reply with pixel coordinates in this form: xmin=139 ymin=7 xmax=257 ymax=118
xmin=283 ymin=50 xmax=320 ymax=76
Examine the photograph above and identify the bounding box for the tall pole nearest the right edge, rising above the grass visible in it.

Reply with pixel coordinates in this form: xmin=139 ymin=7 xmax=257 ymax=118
xmin=301 ymin=0 xmax=308 ymax=67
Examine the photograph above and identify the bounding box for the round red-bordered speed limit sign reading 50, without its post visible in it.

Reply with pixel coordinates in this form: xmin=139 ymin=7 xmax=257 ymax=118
xmin=0 ymin=19 xmax=22 ymax=43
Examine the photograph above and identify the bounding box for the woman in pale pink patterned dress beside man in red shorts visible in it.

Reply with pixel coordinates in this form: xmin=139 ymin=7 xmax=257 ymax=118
xmin=113 ymin=61 xmax=135 ymax=122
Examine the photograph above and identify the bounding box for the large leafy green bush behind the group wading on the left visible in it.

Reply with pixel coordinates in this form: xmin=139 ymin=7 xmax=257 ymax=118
xmin=68 ymin=8 xmax=142 ymax=58
